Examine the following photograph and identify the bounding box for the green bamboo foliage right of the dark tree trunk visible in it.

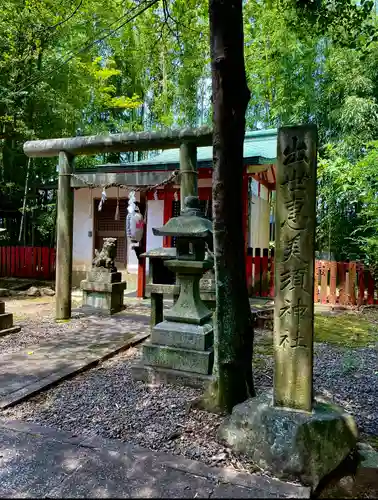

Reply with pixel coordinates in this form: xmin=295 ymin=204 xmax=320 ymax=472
xmin=245 ymin=0 xmax=378 ymax=266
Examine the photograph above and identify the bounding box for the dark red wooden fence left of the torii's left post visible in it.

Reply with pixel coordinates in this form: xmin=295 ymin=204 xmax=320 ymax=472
xmin=0 ymin=247 xmax=55 ymax=280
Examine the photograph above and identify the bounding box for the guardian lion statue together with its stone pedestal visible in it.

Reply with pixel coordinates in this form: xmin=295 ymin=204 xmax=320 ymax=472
xmin=80 ymin=238 xmax=126 ymax=314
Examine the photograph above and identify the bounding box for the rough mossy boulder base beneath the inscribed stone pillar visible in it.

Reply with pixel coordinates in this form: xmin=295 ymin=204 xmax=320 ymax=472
xmin=218 ymin=391 xmax=358 ymax=489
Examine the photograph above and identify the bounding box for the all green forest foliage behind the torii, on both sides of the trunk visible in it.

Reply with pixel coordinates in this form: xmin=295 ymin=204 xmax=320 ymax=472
xmin=0 ymin=0 xmax=378 ymax=260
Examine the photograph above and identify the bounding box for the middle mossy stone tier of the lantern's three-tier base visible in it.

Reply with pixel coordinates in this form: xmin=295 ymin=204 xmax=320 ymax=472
xmin=143 ymin=341 xmax=214 ymax=375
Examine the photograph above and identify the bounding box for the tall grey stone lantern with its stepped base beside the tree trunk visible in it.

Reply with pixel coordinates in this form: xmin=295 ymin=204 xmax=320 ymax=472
xmin=134 ymin=196 xmax=214 ymax=387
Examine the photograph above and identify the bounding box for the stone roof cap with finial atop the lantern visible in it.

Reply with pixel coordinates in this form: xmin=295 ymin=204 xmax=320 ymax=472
xmin=152 ymin=196 xmax=213 ymax=239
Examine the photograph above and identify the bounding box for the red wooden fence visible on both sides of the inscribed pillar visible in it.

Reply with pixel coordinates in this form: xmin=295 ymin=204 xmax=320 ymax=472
xmin=246 ymin=248 xmax=378 ymax=305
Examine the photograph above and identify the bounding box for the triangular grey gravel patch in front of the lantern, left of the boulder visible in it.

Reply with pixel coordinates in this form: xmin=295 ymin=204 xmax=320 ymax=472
xmin=0 ymin=348 xmax=256 ymax=471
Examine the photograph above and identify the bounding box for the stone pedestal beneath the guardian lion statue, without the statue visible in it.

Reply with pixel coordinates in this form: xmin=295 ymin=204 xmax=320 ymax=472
xmin=80 ymin=267 xmax=126 ymax=314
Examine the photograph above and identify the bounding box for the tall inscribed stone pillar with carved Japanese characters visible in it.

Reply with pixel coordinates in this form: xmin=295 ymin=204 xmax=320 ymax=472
xmin=274 ymin=125 xmax=317 ymax=411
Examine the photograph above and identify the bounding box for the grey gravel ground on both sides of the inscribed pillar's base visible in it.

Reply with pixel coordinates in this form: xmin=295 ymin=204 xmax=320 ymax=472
xmin=2 ymin=328 xmax=378 ymax=472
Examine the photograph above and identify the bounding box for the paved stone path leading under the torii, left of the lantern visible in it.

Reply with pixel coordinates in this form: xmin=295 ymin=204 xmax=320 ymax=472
xmin=0 ymin=314 xmax=149 ymax=409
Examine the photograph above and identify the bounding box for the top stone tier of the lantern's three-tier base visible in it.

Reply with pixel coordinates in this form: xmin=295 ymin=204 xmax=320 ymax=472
xmin=151 ymin=321 xmax=214 ymax=351
